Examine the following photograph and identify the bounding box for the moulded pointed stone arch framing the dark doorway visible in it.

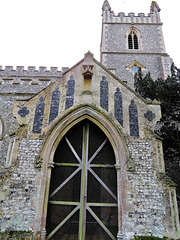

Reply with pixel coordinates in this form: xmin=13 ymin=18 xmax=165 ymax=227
xmin=34 ymin=105 xmax=129 ymax=239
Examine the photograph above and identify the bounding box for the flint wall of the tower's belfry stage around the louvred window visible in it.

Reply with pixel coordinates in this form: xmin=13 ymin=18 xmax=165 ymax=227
xmin=102 ymin=22 xmax=165 ymax=54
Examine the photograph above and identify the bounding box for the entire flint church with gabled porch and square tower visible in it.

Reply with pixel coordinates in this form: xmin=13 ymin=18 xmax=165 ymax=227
xmin=0 ymin=0 xmax=180 ymax=240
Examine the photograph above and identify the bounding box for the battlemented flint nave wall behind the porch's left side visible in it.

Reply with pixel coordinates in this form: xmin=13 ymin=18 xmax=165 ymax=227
xmin=0 ymin=66 xmax=62 ymax=172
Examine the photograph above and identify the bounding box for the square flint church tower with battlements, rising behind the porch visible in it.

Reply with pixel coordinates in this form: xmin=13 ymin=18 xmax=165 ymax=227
xmin=101 ymin=0 xmax=171 ymax=88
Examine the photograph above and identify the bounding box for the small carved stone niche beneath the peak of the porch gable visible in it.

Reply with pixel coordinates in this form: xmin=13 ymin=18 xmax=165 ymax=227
xmin=82 ymin=65 xmax=94 ymax=93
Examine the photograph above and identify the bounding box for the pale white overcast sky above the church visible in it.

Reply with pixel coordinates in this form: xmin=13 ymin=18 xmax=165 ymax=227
xmin=0 ymin=0 xmax=180 ymax=70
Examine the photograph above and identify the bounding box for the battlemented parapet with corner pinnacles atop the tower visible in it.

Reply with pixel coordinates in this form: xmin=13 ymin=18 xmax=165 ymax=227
xmin=102 ymin=0 xmax=162 ymax=24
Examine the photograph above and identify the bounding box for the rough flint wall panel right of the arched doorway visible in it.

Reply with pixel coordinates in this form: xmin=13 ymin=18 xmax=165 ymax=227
xmin=128 ymin=142 xmax=167 ymax=237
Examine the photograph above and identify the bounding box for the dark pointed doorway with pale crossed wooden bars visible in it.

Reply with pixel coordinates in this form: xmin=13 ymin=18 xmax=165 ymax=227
xmin=46 ymin=120 xmax=118 ymax=240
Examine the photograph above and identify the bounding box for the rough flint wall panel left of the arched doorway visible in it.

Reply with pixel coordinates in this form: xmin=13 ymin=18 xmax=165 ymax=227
xmin=0 ymin=139 xmax=42 ymax=232
